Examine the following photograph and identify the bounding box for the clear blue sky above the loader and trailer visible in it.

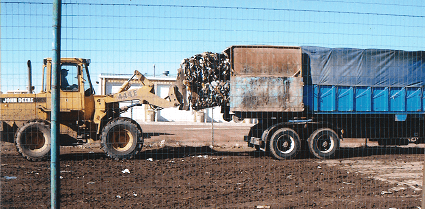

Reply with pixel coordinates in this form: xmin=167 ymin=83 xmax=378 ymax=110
xmin=0 ymin=0 xmax=425 ymax=92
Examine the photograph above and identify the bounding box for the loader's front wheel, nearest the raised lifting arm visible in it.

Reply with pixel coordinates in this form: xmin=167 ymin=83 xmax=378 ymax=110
xmin=101 ymin=118 xmax=143 ymax=160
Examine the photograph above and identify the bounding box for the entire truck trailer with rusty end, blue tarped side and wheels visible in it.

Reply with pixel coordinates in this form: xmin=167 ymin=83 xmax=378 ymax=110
xmin=179 ymin=45 xmax=425 ymax=159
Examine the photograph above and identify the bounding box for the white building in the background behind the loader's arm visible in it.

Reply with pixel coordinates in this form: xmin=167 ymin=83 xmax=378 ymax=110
xmin=98 ymin=73 xmax=225 ymax=122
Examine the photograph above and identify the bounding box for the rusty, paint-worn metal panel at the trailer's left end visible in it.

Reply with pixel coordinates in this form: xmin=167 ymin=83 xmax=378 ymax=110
xmin=226 ymin=46 xmax=304 ymax=112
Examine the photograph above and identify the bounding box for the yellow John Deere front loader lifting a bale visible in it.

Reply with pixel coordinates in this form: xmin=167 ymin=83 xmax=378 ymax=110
xmin=0 ymin=58 xmax=181 ymax=161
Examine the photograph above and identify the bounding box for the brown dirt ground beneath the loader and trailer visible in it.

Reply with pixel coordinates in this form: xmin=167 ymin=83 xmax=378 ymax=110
xmin=1 ymin=123 xmax=424 ymax=208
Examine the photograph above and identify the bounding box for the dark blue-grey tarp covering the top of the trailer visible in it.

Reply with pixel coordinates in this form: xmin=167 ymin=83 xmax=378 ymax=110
xmin=301 ymin=46 xmax=425 ymax=87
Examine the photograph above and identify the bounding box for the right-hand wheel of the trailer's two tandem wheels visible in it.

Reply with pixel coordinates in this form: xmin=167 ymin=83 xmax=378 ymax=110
xmin=308 ymin=128 xmax=339 ymax=158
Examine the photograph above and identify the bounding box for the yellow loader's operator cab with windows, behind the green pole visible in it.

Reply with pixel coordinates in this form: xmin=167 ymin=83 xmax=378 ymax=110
xmin=43 ymin=58 xmax=94 ymax=120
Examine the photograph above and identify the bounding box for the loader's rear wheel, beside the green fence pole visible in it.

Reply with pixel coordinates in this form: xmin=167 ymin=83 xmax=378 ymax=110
xmin=15 ymin=121 xmax=51 ymax=161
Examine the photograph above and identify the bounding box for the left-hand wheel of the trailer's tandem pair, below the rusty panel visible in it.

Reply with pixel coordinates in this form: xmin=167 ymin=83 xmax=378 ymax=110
xmin=269 ymin=128 xmax=301 ymax=160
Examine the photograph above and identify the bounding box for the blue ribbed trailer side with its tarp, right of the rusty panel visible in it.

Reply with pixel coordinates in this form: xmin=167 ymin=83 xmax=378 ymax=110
xmin=301 ymin=47 xmax=425 ymax=114
